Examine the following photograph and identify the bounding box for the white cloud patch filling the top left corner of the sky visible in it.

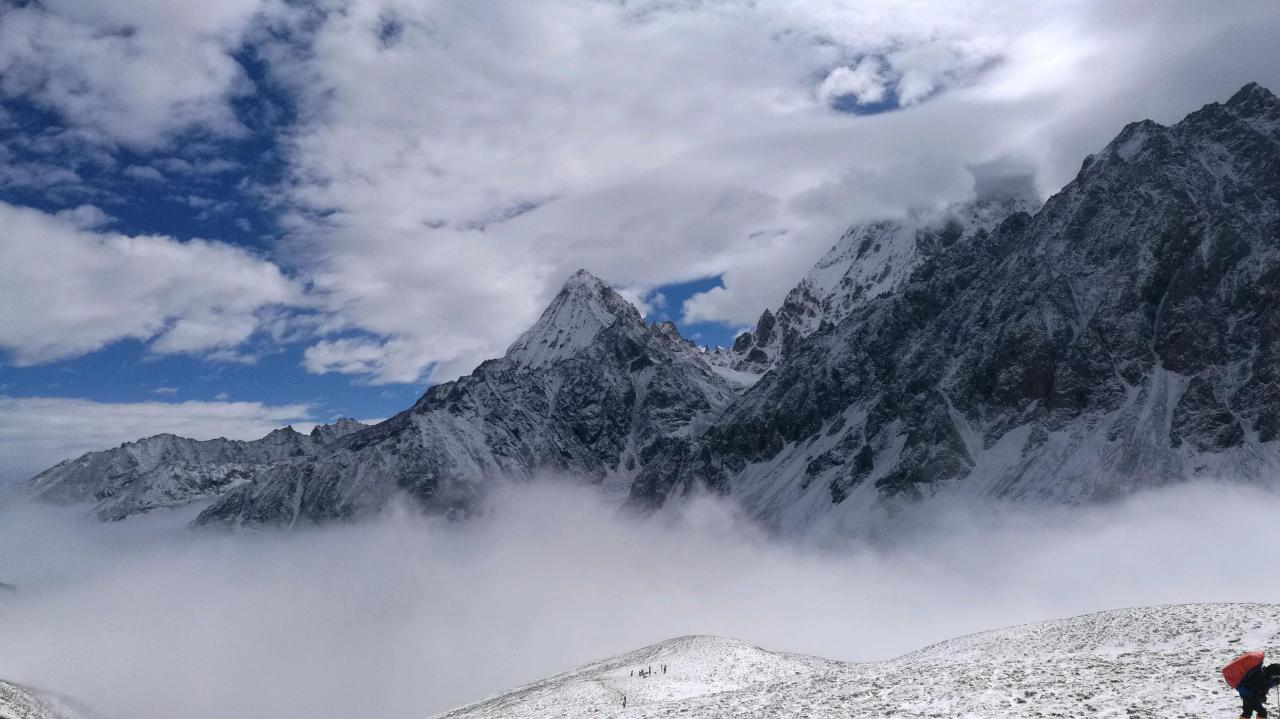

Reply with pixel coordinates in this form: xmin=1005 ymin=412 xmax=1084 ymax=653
xmin=0 ymin=0 xmax=261 ymax=147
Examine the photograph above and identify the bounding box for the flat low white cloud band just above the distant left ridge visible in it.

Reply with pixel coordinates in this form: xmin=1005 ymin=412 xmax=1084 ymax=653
xmin=0 ymin=388 xmax=311 ymax=480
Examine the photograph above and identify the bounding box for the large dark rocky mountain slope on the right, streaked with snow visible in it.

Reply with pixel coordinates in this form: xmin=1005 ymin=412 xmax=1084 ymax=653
xmin=632 ymin=84 xmax=1280 ymax=526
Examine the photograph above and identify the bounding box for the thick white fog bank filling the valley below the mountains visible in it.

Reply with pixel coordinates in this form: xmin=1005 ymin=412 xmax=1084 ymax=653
xmin=0 ymin=475 xmax=1280 ymax=719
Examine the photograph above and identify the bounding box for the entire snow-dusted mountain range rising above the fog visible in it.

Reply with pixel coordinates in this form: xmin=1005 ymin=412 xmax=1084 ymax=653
xmin=20 ymin=84 xmax=1280 ymax=528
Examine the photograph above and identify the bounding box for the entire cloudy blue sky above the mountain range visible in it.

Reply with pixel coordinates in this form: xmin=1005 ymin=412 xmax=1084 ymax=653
xmin=0 ymin=0 xmax=1280 ymax=477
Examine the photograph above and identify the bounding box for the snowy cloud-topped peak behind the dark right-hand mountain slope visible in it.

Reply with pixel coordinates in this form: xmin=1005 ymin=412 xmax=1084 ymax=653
xmin=708 ymin=183 xmax=1039 ymax=372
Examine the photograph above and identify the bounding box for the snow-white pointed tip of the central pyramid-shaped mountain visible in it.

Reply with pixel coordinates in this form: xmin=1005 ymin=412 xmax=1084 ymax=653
xmin=507 ymin=270 xmax=644 ymax=367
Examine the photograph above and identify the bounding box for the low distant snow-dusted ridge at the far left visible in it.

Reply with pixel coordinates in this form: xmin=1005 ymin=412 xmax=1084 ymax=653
xmin=26 ymin=418 xmax=365 ymax=519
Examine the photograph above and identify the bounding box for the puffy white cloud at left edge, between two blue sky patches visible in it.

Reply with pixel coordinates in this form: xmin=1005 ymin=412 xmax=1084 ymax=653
xmin=0 ymin=202 xmax=303 ymax=365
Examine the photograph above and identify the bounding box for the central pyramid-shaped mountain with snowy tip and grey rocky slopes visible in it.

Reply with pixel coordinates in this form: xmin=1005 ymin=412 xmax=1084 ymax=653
xmin=188 ymin=271 xmax=735 ymax=525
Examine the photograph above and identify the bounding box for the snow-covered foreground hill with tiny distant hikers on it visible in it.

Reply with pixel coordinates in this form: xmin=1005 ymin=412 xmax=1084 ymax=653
xmin=439 ymin=604 xmax=1280 ymax=719
